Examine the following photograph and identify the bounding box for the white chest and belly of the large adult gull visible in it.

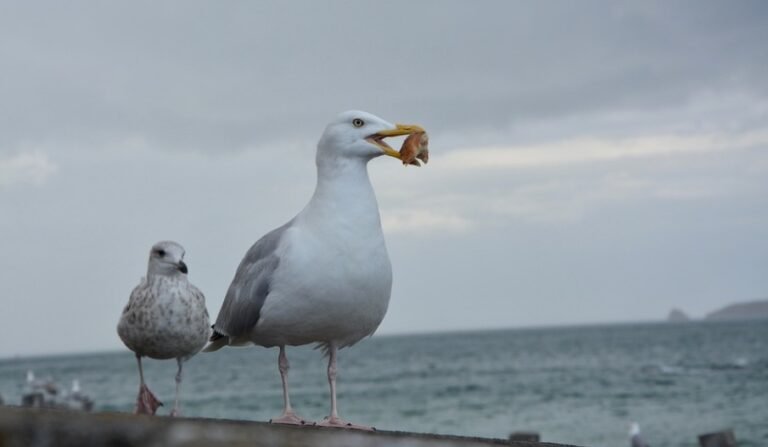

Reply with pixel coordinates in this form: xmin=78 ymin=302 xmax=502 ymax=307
xmin=251 ymin=166 xmax=392 ymax=347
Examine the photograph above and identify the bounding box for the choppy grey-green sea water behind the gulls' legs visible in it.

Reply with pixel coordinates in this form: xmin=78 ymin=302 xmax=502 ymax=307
xmin=0 ymin=320 xmax=768 ymax=447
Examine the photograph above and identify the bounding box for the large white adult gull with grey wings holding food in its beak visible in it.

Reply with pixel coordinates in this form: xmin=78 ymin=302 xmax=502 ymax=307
xmin=205 ymin=111 xmax=423 ymax=429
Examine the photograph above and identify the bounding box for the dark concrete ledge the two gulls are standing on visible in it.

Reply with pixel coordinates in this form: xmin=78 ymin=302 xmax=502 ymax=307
xmin=0 ymin=407 xmax=574 ymax=447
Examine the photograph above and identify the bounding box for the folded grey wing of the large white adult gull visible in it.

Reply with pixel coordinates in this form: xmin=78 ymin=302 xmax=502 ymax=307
xmin=211 ymin=221 xmax=293 ymax=341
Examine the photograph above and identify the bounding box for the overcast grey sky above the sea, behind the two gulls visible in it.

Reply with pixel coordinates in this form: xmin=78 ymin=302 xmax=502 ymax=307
xmin=0 ymin=0 xmax=768 ymax=356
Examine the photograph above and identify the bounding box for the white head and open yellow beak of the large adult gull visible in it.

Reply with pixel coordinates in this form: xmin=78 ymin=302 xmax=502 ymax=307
xmin=317 ymin=110 xmax=424 ymax=162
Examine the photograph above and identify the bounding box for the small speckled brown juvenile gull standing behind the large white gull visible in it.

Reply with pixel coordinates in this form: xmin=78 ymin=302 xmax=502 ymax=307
xmin=117 ymin=241 xmax=210 ymax=416
